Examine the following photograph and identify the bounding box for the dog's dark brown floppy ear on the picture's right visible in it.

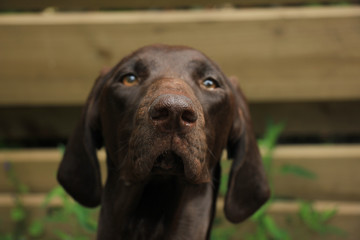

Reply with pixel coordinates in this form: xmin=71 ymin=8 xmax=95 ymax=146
xmin=225 ymin=78 xmax=270 ymax=223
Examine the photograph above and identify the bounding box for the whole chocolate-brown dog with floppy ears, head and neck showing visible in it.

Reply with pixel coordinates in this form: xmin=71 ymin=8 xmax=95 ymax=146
xmin=58 ymin=45 xmax=269 ymax=240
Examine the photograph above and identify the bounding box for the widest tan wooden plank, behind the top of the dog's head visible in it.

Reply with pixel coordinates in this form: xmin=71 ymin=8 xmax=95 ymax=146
xmin=0 ymin=7 xmax=360 ymax=105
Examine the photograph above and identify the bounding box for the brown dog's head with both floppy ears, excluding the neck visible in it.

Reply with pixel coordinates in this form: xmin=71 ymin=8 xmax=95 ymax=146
xmin=58 ymin=45 xmax=269 ymax=222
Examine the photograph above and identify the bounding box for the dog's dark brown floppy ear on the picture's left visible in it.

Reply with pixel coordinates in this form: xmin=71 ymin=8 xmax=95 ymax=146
xmin=57 ymin=66 xmax=108 ymax=207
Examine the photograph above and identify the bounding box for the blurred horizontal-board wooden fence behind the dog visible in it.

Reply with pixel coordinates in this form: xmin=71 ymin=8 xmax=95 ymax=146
xmin=0 ymin=0 xmax=360 ymax=240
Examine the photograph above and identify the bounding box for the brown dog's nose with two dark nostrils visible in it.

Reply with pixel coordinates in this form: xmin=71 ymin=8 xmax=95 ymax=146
xmin=149 ymin=94 xmax=198 ymax=132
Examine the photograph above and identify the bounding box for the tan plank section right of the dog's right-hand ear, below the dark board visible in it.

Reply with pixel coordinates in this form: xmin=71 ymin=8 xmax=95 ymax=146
xmin=274 ymin=145 xmax=360 ymax=200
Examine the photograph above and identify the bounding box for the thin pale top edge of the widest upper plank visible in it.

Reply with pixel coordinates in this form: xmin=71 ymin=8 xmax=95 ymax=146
xmin=0 ymin=6 xmax=359 ymax=26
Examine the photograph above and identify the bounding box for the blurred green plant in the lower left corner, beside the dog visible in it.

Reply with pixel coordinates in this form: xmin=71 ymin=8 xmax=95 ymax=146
xmin=0 ymin=158 xmax=98 ymax=240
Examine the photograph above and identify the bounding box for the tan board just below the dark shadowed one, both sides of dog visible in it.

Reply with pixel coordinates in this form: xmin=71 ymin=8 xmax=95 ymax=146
xmin=0 ymin=145 xmax=360 ymax=201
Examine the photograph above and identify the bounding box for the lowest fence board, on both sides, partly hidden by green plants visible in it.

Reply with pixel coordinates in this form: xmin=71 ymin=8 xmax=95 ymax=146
xmin=0 ymin=197 xmax=360 ymax=240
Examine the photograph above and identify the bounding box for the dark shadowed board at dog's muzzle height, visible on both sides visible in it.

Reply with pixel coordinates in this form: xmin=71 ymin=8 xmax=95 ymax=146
xmin=0 ymin=101 xmax=360 ymax=142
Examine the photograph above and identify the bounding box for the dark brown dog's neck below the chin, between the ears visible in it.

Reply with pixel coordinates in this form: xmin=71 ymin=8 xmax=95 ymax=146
xmin=98 ymin=171 xmax=216 ymax=240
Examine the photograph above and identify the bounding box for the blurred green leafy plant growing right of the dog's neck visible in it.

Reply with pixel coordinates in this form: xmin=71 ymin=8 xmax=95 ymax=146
xmin=211 ymin=122 xmax=345 ymax=240
